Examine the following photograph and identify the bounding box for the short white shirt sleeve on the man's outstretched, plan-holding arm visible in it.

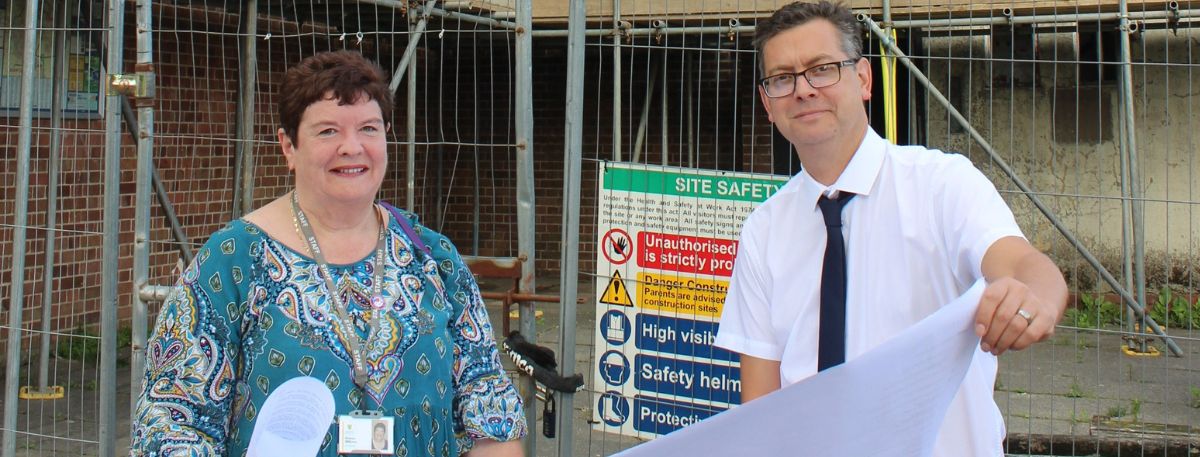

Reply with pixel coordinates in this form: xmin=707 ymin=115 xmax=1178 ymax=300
xmin=940 ymin=155 xmax=1025 ymax=283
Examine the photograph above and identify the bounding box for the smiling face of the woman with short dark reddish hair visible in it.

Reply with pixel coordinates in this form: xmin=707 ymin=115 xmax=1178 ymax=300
xmin=278 ymin=95 xmax=388 ymax=204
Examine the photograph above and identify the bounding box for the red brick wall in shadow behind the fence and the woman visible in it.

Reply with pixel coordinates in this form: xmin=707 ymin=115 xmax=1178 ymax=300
xmin=0 ymin=12 xmax=770 ymax=340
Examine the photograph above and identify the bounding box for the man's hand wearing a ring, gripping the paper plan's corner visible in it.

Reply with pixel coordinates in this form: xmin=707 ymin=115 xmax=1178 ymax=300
xmin=976 ymin=277 xmax=1058 ymax=355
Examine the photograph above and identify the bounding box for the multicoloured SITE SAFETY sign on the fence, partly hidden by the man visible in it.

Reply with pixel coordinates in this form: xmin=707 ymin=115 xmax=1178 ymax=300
xmin=592 ymin=163 xmax=787 ymax=438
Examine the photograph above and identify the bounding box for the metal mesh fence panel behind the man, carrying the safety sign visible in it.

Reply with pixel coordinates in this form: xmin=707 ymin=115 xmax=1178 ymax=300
xmin=568 ymin=1 xmax=1200 ymax=456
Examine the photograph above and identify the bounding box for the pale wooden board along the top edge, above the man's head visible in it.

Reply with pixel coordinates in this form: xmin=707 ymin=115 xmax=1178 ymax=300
xmin=533 ymin=0 xmax=1168 ymax=25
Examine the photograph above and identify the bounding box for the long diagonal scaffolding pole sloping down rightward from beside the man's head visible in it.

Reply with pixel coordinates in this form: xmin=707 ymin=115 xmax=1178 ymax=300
xmin=858 ymin=14 xmax=1183 ymax=356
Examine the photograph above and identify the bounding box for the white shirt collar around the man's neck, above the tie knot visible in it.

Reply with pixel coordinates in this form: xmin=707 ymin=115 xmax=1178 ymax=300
xmin=798 ymin=127 xmax=889 ymax=208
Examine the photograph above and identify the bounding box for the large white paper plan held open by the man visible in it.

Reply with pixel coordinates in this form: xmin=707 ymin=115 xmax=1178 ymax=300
xmin=617 ymin=279 xmax=986 ymax=457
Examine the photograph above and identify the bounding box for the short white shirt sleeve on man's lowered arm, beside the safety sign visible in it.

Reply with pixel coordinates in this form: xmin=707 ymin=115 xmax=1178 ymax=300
xmin=714 ymin=215 xmax=784 ymax=360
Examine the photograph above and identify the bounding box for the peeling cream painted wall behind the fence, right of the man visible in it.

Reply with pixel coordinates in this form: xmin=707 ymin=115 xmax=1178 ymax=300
xmin=925 ymin=29 xmax=1200 ymax=287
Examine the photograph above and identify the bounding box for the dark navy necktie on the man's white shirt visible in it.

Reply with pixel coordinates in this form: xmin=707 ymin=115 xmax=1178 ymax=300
xmin=817 ymin=192 xmax=854 ymax=372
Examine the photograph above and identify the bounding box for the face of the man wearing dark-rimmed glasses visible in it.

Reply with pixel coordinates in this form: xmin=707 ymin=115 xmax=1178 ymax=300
xmin=758 ymin=19 xmax=871 ymax=148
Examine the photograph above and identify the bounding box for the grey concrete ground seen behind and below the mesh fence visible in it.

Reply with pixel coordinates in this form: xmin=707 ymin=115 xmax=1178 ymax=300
xmin=2 ymin=272 xmax=1200 ymax=457
